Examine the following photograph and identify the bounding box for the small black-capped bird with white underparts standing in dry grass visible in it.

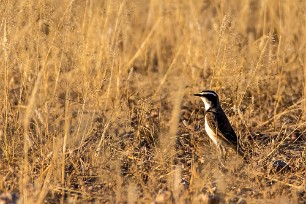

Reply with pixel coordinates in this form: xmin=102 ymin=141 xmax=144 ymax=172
xmin=194 ymin=90 xmax=244 ymax=157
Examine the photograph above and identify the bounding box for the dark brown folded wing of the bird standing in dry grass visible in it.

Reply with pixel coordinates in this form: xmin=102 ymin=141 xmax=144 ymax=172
xmin=205 ymin=109 xmax=243 ymax=155
